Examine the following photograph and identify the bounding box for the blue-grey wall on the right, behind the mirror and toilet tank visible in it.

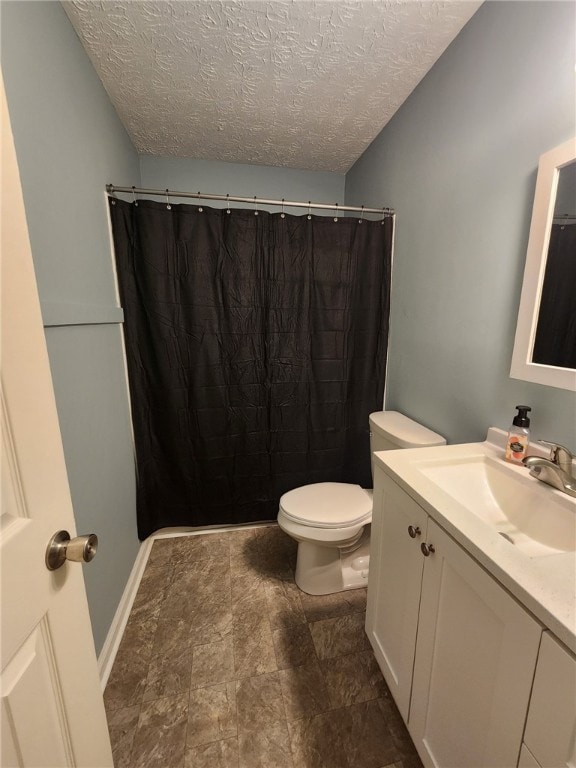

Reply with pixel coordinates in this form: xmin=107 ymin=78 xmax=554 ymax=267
xmin=346 ymin=1 xmax=576 ymax=449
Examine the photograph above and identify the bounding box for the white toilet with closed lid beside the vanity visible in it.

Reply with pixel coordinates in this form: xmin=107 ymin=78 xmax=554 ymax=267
xmin=278 ymin=411 xmax=446 ymax=595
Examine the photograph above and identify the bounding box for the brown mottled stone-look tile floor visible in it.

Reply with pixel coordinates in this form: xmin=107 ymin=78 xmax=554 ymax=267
xmin=104 ymin=526 xmax=421 ymax=768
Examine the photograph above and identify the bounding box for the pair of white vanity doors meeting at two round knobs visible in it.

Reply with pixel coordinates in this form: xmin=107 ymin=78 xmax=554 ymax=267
xmin=366 ymin=467 xmax=542 ymax=768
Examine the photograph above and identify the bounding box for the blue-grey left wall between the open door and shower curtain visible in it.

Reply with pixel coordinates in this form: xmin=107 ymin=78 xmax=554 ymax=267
xmin=0 ymin=0 xmax=140 ymax=651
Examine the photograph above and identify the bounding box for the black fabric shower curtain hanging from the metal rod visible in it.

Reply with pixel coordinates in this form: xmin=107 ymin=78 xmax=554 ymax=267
xmin=110 ymin=198 xmax=393 ymax=539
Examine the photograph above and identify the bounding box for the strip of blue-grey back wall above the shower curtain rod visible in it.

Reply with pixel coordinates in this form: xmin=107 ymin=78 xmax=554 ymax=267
xmin=138 ymin=155 xmax=345 ymax=215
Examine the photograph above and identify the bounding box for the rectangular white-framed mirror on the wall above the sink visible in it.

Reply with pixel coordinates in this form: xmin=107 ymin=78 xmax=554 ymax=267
xmin=510 ymin=138 xmax=576 ymax=392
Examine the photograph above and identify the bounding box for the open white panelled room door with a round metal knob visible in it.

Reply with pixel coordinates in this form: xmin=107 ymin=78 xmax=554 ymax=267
xmin=0 ymin=75 xmax=113 ymax=768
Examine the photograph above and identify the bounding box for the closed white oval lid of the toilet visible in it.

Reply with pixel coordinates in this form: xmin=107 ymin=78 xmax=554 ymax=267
xmin=280 ymin=483 xmax=372 ymax=528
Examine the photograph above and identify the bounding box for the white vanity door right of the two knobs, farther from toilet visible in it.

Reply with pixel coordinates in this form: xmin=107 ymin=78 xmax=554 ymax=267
xmin=408 ymin=521 xmax=541 ymax=768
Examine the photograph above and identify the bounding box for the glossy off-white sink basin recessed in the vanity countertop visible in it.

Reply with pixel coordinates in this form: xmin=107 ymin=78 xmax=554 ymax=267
xmin=416 ymin=455 xmax=576 ymax=557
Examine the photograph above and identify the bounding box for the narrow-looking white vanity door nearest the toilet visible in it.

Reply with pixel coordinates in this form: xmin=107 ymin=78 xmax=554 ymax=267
xmin=366 ymin=468 xmax=427 ymax=721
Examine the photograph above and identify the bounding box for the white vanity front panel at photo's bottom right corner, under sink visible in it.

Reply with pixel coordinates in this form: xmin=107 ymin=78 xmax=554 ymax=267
xmin=524 ymin=632 xmax=576 ymax=768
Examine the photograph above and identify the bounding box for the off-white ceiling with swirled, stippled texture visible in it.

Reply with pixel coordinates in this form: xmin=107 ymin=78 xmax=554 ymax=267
xmin=63 ymin=0 xmax=481 ymax=172
